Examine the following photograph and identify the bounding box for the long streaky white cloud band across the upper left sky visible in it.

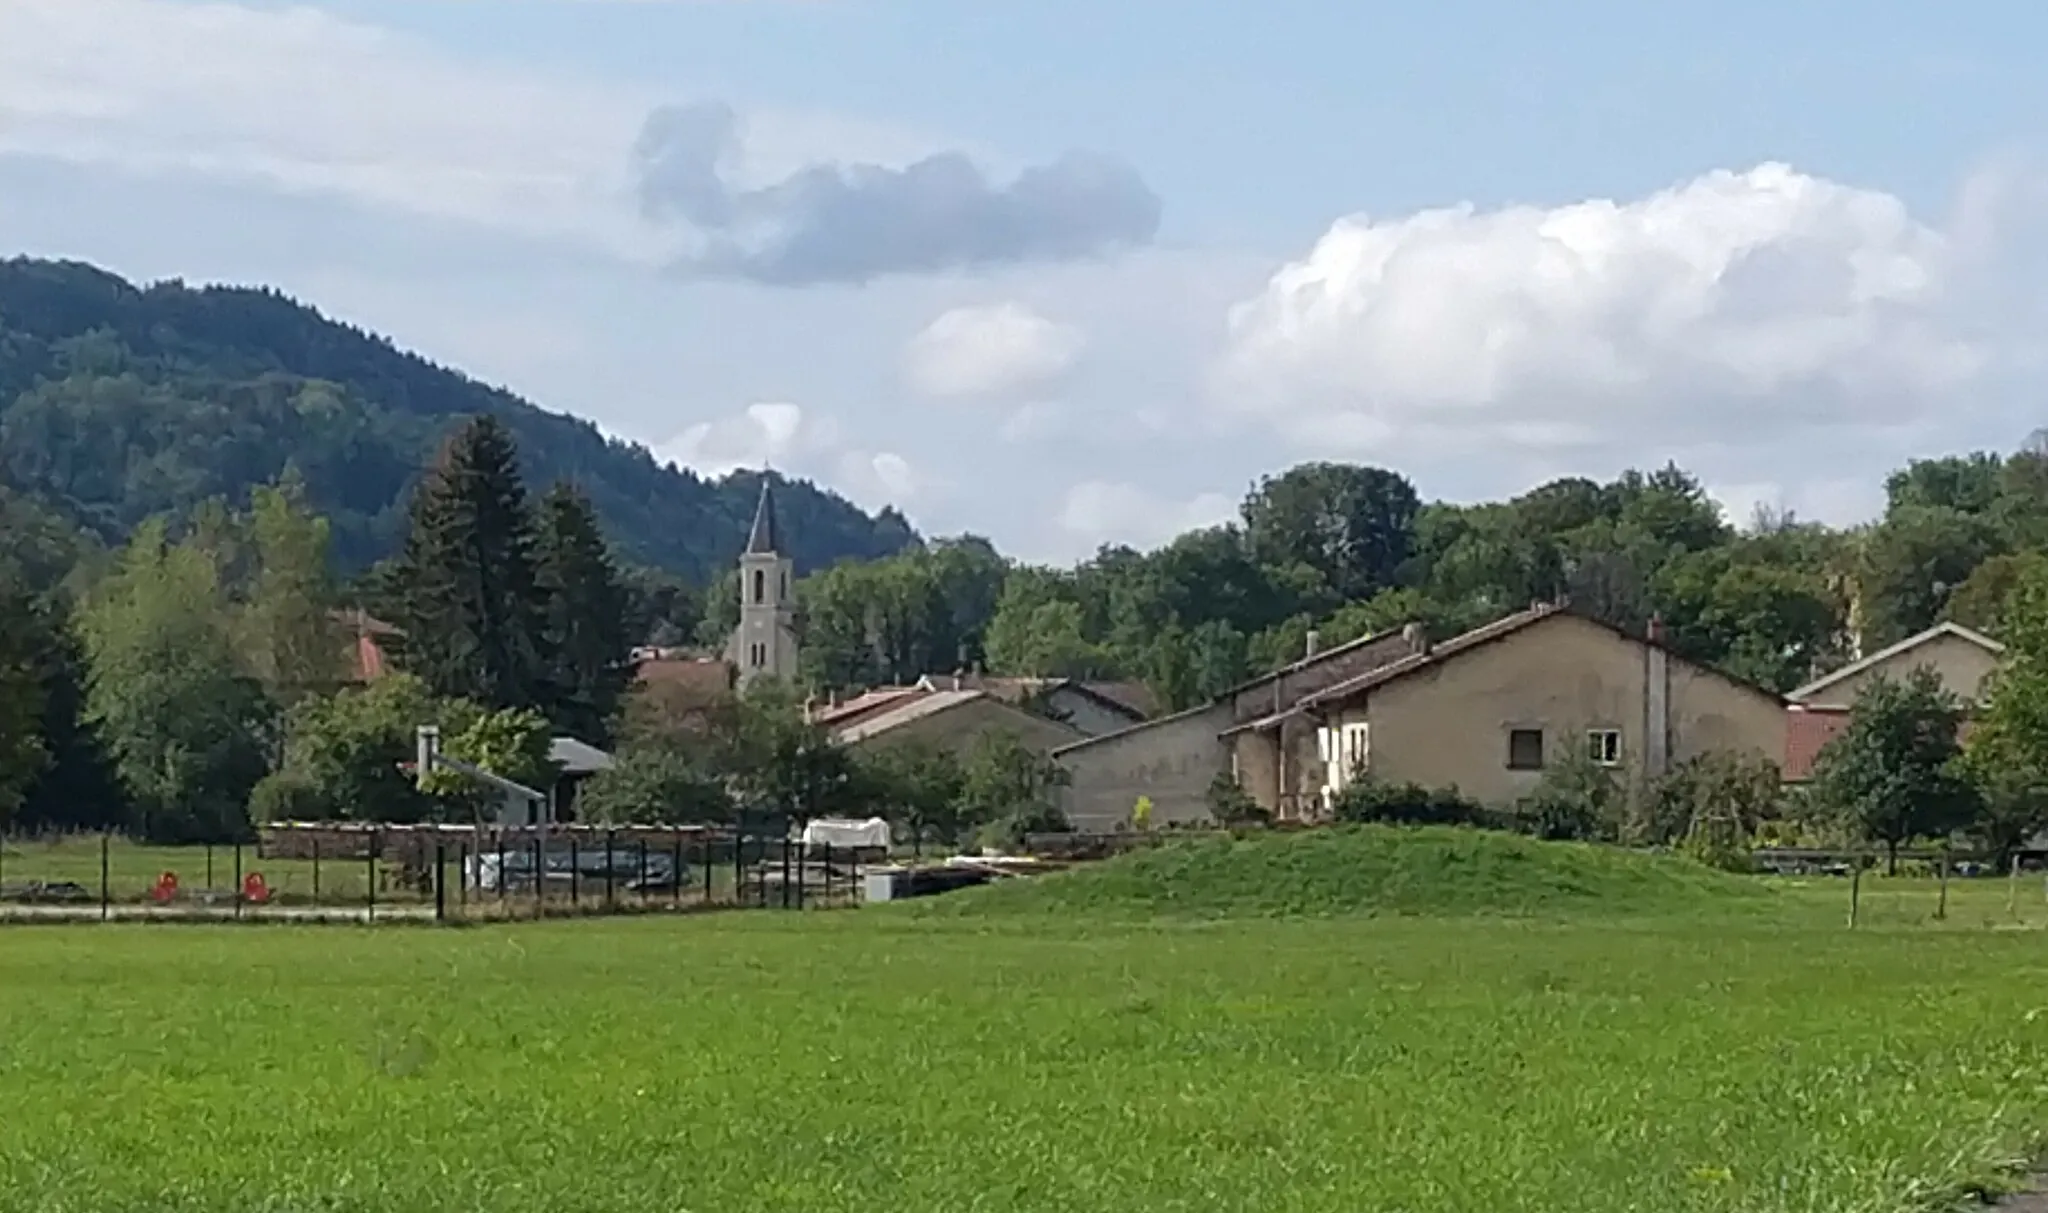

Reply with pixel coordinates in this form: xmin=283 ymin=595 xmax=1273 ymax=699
xmin=0 ymin=0 xmax=932 ymax=258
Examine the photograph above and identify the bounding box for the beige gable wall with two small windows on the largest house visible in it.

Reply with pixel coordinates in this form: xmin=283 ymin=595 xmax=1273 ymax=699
xmin=1325 ymin=615 xmax=1786 ymax=805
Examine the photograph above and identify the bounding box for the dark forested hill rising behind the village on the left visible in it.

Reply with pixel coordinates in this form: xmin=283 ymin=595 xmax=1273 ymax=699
xmin=0 ymin=258 xmax=915 ymax=584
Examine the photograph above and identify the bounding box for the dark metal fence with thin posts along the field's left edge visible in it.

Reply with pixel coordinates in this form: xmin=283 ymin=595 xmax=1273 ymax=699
xmin=0 ymin=826 xmax=883 ymax=922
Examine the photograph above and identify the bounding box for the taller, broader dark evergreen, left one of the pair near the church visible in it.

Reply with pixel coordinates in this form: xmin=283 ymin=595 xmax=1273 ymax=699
xmin=391 ymin=416 xmax=553 ymax=709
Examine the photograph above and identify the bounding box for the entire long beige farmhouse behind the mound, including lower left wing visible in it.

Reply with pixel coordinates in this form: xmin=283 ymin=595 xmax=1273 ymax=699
xmin=1057 ymin=604 xmax=1786 ymax=830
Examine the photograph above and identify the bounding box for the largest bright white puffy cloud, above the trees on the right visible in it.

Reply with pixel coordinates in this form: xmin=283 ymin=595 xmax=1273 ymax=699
xmin=1219 ymin=164 xmax=1995 ymax=457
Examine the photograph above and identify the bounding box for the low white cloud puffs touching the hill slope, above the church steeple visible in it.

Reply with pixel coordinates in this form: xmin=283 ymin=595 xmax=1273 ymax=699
xmin=653 ymin=402 xmax=924 ymax=510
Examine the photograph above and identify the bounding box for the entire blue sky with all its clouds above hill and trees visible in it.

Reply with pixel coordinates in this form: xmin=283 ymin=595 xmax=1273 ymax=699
xmin=0 ymin=0 xmax=2048 ymax=559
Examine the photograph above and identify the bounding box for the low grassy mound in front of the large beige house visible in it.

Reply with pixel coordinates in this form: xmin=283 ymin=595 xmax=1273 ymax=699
xmin=920 ymin=826 xmax=1767 ymax=918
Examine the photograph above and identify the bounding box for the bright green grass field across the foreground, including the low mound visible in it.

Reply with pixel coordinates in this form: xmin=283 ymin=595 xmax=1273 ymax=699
xmin=0 ymin=823 xmax=2048 ymax=1213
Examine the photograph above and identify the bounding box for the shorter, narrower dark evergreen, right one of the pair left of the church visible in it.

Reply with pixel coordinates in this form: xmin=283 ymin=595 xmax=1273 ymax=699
xmin=537 ymin=484 xmax=633 ymax=746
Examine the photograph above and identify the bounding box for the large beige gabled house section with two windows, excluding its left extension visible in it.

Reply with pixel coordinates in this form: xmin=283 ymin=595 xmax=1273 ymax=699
xmin=1298 ymin=607 xmax=1786 ymax=805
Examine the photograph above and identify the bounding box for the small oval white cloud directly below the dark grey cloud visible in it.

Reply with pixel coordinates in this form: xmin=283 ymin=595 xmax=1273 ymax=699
xmin=903 ymin=303 xmax=1087 ymax=398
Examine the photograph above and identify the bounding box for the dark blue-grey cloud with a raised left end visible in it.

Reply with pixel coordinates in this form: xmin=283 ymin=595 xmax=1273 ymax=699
xmin=635 ymin=102 xmax=1159 ymax=287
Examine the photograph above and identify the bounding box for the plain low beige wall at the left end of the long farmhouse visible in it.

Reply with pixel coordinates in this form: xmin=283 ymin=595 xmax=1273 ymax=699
xmin=1055 ymin=703 xmax=1231 ymax=832
